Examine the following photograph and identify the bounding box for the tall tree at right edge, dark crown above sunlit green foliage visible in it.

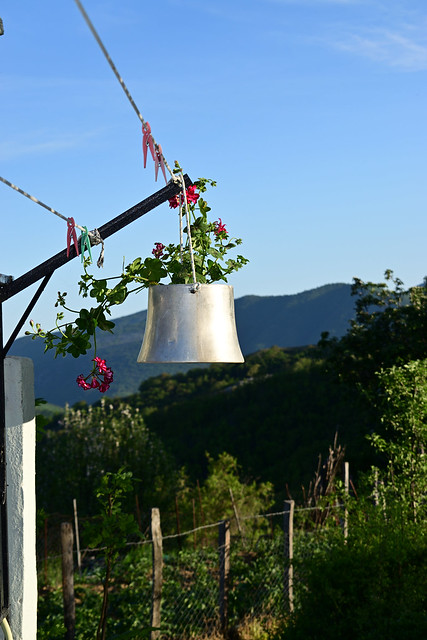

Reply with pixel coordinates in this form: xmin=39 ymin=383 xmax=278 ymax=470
xmin=321 ymin=270 xmax=427 ymax=510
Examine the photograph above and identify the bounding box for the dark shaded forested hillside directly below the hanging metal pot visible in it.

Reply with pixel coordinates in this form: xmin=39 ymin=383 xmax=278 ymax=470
xmin=114 ymin=347 xmax=369 ymax=495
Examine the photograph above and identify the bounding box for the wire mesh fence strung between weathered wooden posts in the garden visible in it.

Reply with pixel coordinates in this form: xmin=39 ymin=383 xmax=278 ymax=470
xmin=38 ymin=501 xmax=342 ymax=640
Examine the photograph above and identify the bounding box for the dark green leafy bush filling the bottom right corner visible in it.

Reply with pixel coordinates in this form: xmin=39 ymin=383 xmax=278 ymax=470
xmin=276 ymin=504 xmax=427 ymax=640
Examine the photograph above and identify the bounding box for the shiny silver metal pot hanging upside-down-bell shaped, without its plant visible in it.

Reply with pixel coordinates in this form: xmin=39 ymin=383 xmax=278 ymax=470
xmin=138 ymin=284 xmax=243 ymax=362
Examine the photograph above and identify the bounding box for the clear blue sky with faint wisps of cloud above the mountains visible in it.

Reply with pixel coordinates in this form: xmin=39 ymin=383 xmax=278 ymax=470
xmin=0 ymin=0 xmax=427 ymax=340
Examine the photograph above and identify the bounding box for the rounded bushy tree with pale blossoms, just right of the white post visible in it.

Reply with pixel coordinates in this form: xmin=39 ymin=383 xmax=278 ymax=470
xmin=37 ymin=400 xmax=176 ymax=515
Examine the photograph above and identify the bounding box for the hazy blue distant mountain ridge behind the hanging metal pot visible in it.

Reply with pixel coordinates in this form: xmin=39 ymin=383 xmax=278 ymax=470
xmin=9 ymin=283 xmax=354 ymax=406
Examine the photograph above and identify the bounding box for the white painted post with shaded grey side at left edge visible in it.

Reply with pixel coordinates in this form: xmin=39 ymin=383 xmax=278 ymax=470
xmin=0 ymin=357 xmax=37 ymax=640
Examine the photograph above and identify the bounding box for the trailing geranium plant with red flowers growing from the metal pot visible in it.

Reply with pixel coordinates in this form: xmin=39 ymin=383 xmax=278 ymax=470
xmin=26 ymin=178 xmax=248 ymax=393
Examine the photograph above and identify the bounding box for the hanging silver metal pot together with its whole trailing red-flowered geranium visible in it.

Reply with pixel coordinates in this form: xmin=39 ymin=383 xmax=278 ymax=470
xmin=29 ymin=175 xmax=248 ymax=393
